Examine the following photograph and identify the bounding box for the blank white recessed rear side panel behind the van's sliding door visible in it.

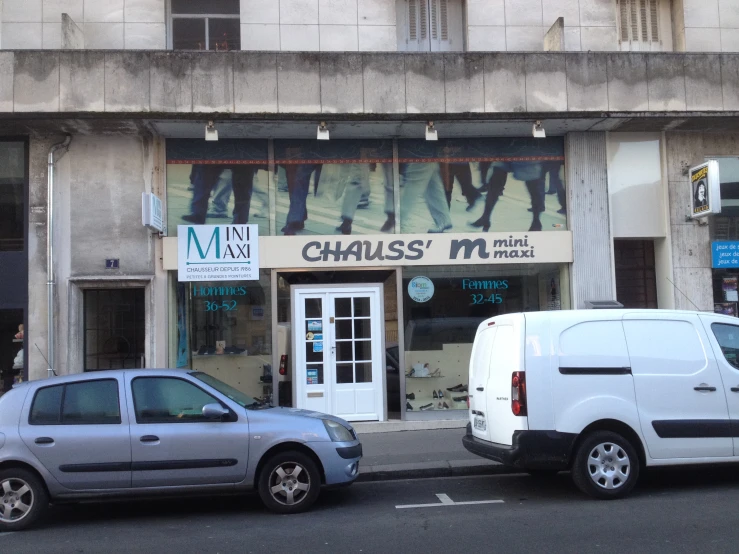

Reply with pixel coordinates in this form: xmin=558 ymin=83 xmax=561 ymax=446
xmin=559 ymin=321 xmax=630 ymax=371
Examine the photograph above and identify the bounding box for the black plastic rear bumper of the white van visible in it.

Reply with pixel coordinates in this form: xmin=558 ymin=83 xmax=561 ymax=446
xmin=462 ymin=423 xmax=577 ymax=469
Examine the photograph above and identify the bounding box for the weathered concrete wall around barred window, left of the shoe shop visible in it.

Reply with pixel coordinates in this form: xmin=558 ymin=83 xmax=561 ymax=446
xmin=29 ymin=135 xmax=167 ymax=379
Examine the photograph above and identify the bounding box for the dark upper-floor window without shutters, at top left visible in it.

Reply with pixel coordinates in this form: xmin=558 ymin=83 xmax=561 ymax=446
xmin=170 ymin=0 xmax=241 ymax=51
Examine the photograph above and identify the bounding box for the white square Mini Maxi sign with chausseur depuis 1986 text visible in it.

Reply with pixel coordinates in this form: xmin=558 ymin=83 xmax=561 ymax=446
xmin=177 ymin=225 xmax=259 ymax=281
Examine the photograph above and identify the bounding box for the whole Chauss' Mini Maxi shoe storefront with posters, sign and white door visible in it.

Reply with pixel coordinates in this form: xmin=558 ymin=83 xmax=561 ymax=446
xmin=164 ymin=138 xmax=573 ymax=421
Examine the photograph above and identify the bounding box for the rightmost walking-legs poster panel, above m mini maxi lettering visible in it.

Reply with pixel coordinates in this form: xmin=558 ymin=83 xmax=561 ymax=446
xmin=398 ymin=138 xmax=567 ymax=233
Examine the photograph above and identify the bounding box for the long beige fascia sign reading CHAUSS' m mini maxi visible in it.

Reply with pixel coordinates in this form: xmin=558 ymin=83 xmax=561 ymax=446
xmin=164 ymin=230 xmax=573 ymax=270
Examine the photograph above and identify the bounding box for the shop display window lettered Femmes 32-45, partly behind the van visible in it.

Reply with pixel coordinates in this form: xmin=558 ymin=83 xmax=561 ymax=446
xmin=403 ymin=265 xmax=567 ymax=414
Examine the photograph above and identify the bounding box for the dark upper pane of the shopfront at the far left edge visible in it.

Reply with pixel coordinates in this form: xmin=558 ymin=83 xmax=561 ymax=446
xmin=0 ymin=141 xmax=26 ymax=252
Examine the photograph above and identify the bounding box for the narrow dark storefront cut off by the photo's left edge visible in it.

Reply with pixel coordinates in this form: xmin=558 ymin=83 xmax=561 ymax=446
xmin=0 ymin=139 xmax=28 ymax=392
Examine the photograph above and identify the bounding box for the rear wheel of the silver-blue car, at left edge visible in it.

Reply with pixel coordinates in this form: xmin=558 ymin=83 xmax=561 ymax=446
xmin=0 ymin=468 xmax=49 ymax=531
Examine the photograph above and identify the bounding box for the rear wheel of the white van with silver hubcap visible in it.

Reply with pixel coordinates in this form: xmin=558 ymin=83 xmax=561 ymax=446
xmin=572 ymin=431 xmax=639 ymax=500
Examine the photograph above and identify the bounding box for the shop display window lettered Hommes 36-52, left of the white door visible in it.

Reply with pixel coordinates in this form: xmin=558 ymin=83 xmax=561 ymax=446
xmin=176 ymin=270 xmax=273 ymax=403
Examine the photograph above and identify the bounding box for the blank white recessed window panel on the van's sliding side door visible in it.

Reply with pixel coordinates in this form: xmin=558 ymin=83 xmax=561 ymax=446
xmin=624 ymin=320 xmax=707 ymax=375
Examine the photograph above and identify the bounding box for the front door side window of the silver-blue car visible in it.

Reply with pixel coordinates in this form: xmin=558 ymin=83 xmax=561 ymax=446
xmin=131 ymin=377 xmax=220 ymax=423
